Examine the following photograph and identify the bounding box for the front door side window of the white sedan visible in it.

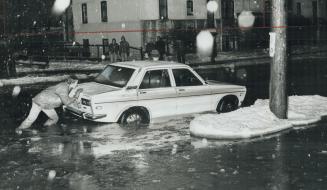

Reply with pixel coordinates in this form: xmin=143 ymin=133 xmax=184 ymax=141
xmin=173 ymin=69 xmax=203 ymax=86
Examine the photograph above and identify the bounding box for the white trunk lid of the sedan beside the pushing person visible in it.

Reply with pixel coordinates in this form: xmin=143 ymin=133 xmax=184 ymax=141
xmin=77 ymin=82 xmax=120 ymax=96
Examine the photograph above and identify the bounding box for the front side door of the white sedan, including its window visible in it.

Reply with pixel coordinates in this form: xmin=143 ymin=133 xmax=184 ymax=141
xmin=172 ymin=68 xmax=211 ymax=114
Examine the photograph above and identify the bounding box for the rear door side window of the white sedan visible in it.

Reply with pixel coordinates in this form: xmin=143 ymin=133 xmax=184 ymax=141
xmin=140 ymin=69 xmax=171 ymax=89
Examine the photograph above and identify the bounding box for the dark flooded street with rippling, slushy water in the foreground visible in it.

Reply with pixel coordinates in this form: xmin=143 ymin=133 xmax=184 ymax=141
xmin=0 ymin=86 xmax=327 ymax=190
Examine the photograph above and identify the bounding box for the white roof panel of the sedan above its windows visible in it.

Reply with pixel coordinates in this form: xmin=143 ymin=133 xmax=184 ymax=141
xmin=112 ymin=60 xmax=188 ymax=69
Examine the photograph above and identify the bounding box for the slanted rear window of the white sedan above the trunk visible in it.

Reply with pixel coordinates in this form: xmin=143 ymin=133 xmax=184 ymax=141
xmin=95 ymin=65 xmax=135 ymax=88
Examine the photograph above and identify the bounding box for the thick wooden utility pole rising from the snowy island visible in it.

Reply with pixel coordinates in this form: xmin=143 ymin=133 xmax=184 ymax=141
xmin=269 ymin=0 xmax=288 ymax=119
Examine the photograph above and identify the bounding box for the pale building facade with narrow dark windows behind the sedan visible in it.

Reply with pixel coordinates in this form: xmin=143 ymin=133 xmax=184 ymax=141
xmin=72 ymin=0 xmax=220 ymax=56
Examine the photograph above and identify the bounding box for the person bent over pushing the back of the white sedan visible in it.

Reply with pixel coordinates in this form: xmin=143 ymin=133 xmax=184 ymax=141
xmin=16 ymin=78 xmax=82 ymax=133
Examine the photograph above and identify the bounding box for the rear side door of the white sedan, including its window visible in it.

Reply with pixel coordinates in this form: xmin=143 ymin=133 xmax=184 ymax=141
xmin=138 ymin=69 xmax=177 ymax=118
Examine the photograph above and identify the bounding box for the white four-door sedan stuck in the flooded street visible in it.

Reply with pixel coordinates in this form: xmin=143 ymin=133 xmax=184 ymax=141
xmin=64 ymin=61 xmax=246 ymax=124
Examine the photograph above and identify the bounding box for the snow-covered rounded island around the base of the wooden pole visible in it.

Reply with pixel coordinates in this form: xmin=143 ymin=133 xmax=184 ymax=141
xmin=190 ymin=95 xmax=327 ymax=139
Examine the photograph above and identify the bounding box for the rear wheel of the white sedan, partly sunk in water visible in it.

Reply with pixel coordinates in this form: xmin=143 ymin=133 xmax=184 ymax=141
xmin=120 ymin=109 xmax=149 ymax=126
